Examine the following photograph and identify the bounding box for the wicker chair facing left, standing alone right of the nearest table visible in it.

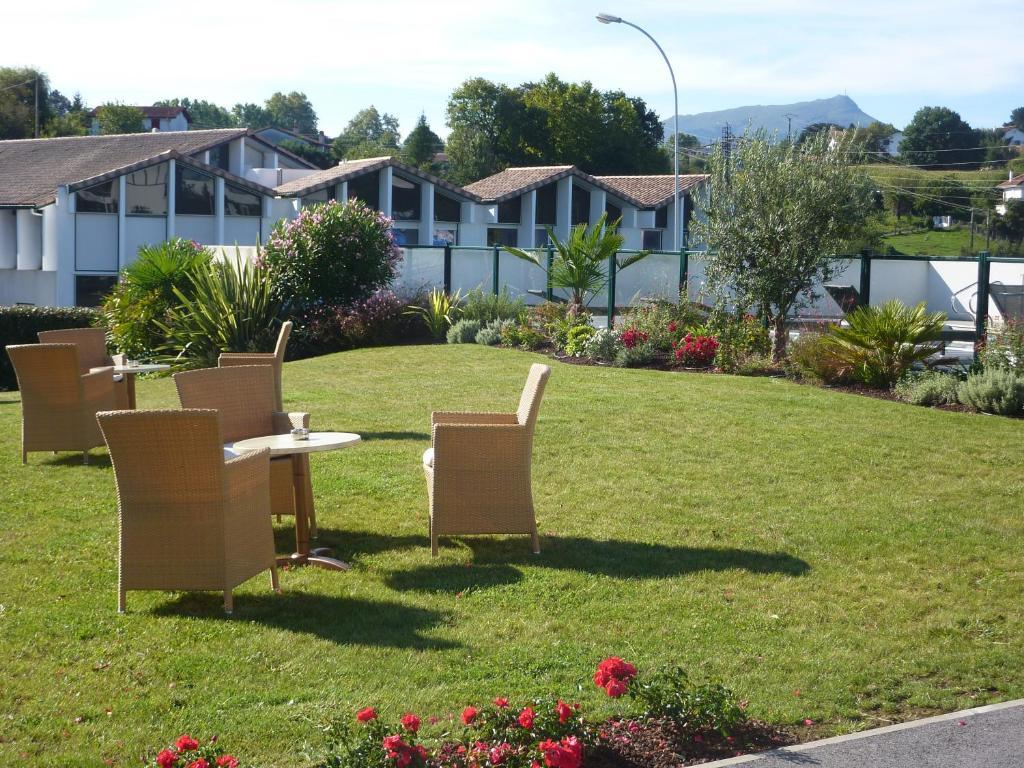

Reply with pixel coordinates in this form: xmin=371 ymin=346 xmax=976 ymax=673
xmin=423 ymin=364 xmax=551 ymax=556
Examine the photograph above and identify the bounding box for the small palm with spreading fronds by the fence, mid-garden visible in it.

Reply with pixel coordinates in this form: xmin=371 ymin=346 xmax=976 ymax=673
xmin=505 ymin=213 xmax=650 ymax=317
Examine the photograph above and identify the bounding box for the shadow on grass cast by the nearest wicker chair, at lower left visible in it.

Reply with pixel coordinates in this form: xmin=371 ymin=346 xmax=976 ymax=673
xmin=153 ymin=589 xmax=460 ymax=650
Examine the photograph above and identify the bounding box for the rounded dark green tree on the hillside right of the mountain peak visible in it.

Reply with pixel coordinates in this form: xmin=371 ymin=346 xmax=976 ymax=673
xmin=900 ymin=106 xmax=984 ymax=169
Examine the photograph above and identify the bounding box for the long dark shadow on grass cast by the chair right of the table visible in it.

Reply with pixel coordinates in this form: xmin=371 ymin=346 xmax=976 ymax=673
xmin=385 ymin=537 xmax=811 ymax=592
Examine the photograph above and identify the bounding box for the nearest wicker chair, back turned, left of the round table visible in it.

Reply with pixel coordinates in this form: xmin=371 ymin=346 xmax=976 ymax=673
xmin=96 ymin=411 xmax=280 ymax=613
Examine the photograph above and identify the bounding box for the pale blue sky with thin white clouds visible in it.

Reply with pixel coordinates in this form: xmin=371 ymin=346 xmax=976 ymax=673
xmin=8 ymin=0 xmax=1024 ymax=136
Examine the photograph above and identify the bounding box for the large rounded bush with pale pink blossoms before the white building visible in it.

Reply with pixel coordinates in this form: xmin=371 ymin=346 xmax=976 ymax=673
xmin=260 ymin=200 xmax=401 ymax=315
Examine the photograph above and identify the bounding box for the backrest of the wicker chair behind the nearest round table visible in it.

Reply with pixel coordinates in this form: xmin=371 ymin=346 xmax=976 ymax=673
xmin=174 ymin=366 xmax=278 ymax=442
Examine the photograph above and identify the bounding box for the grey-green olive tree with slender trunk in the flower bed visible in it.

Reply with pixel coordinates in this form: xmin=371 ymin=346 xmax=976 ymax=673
xmin=693 ymin=131 xmax=872 ymax=360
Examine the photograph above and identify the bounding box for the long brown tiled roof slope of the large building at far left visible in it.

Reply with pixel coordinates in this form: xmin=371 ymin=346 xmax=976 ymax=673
xmin=0 ymin=128 xmax=249 ymax=207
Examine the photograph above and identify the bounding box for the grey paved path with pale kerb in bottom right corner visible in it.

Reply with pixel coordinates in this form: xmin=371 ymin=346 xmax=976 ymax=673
xmin=705 ymin=700 xmax=1024 ymax=768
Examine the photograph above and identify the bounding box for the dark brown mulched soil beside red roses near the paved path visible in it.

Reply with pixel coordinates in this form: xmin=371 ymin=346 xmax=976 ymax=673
xmin=585 ymin=720 xmax=804 ymax=768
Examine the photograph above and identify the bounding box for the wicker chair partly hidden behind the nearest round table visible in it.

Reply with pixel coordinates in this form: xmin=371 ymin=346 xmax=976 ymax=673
xmin=174 ymin=365 xmax=316 ymax=538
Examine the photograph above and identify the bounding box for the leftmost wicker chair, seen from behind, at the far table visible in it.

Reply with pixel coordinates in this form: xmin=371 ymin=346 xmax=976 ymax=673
xmin=7 ymin=344 xmax=118 ymax=464
